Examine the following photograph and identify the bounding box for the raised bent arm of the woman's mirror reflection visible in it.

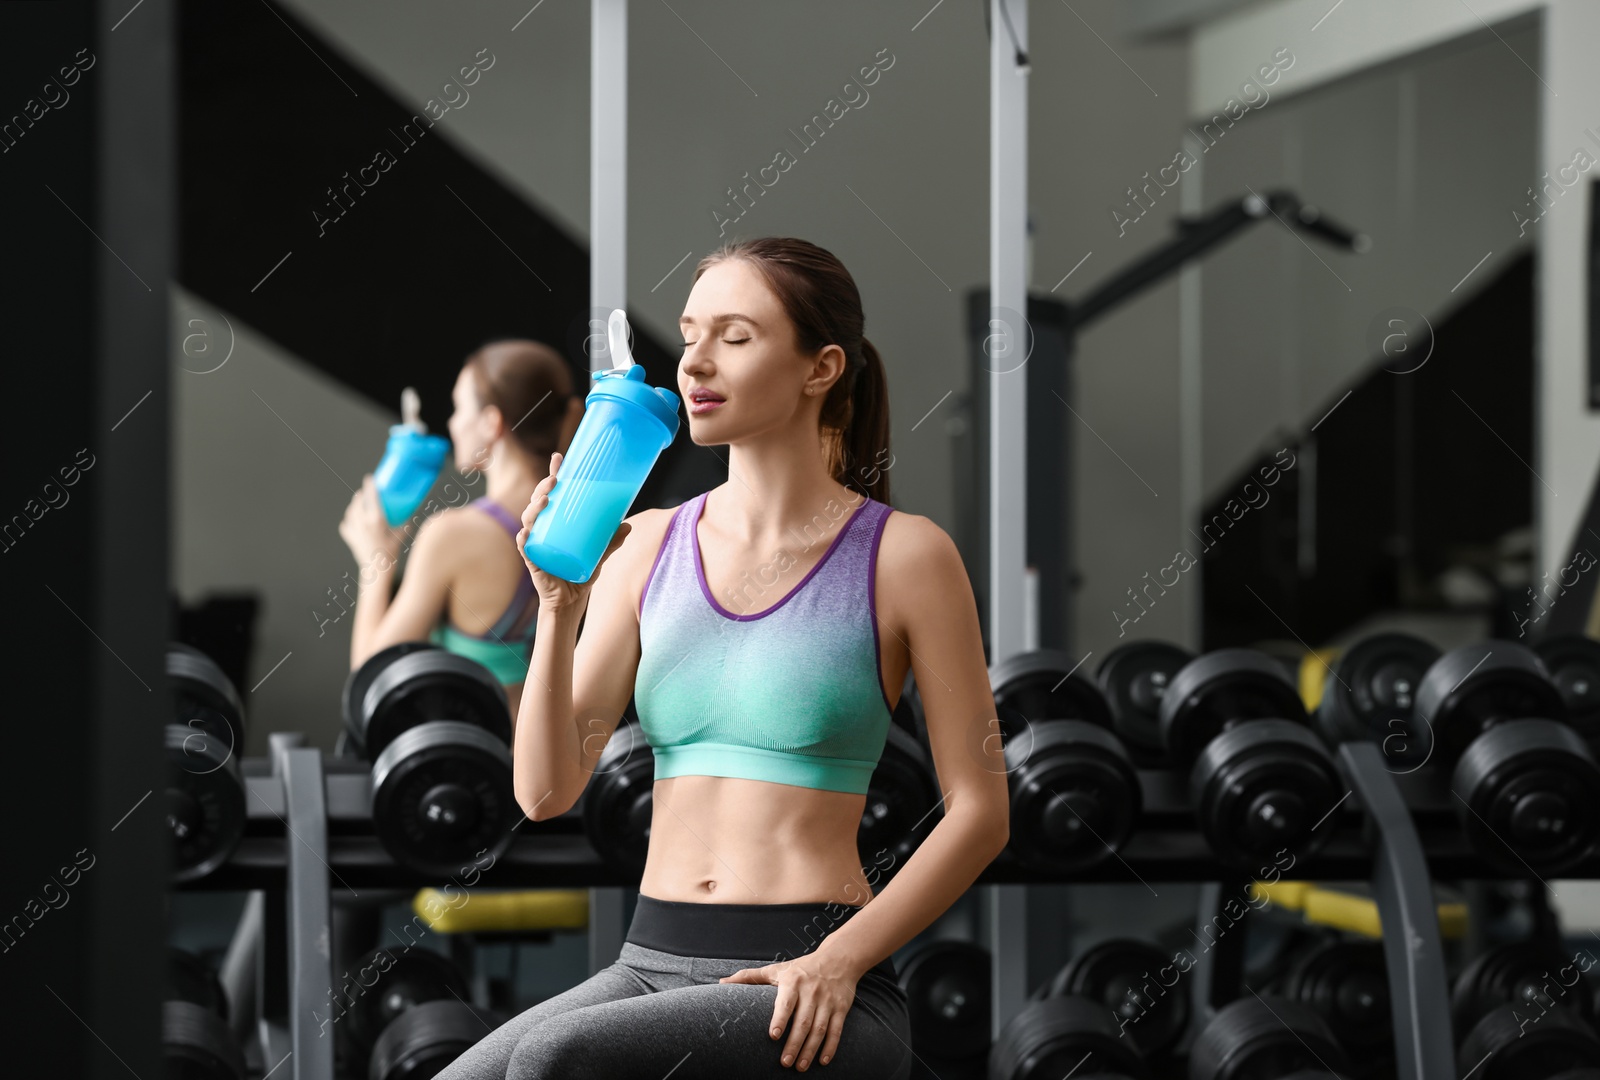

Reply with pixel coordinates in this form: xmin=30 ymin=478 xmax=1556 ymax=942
xmin=339 ymin=475 xmax=456 ymax=670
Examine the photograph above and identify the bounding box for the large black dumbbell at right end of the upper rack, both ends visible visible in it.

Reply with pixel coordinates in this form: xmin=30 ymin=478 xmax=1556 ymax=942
xmin=1416 ymin=642 xmax=1600 ymax=874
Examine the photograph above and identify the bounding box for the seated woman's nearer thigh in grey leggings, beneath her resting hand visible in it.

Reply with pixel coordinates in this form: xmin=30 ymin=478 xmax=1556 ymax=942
xmin=508 ymin=960 xmax=912 ymax=1080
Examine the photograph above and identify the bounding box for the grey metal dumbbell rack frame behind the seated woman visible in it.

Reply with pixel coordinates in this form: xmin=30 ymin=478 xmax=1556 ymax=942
xmin=178 ymin=734 xmax=1600 ymax=1080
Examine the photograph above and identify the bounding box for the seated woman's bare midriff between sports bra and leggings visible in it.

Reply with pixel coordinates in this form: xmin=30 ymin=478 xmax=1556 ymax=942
xmin=638 ymin=776 xmax=872 ymax=906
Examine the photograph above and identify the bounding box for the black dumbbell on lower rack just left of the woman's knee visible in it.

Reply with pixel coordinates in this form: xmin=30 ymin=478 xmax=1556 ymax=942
xmin=333 ymin=947 xmax=492 ymax=1080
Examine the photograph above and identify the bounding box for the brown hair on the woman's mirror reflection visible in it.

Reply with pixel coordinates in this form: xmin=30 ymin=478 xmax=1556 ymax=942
xmin=462 ymin=338 xmax=573 ymax=458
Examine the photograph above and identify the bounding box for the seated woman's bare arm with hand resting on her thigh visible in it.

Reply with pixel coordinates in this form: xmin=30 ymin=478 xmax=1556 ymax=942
xmin=723 ymin=512 xmax=1010 ymax=1070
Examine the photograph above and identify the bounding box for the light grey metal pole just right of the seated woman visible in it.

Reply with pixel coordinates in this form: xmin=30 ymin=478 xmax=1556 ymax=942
xmin=986 ymin=0 xmax=1032 ymax=1038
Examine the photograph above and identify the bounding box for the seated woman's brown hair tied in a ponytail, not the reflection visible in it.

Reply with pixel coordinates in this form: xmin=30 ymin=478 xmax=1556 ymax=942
xmin=694 ymin=237 xmax=890 ymax=502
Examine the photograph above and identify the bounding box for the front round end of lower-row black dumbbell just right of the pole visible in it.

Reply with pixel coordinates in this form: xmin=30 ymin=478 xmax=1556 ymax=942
xmin=989 ymin=997 xmax=1150 ymax=1080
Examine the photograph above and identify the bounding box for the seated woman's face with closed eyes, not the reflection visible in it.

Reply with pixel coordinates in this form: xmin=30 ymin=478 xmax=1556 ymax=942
xmin=678 ymin=259 xmax=843 ymax=445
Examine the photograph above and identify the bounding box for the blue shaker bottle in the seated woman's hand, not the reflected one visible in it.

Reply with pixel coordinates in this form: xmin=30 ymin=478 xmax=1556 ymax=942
xmin=523 ymin=309 xmax=678 ymax=582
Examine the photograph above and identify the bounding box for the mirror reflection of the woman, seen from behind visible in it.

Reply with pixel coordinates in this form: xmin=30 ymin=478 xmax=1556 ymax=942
xmin=339 ymin=341 xmax=584 ymax=718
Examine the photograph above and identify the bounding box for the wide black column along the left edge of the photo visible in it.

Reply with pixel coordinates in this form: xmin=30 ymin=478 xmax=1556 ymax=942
xmin=0 ymin=0 xmax=174 ymax=1077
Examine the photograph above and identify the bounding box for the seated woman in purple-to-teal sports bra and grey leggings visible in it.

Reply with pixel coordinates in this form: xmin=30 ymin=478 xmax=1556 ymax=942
xmin=440 ymin=238 xmax=1008 ymax=1080
